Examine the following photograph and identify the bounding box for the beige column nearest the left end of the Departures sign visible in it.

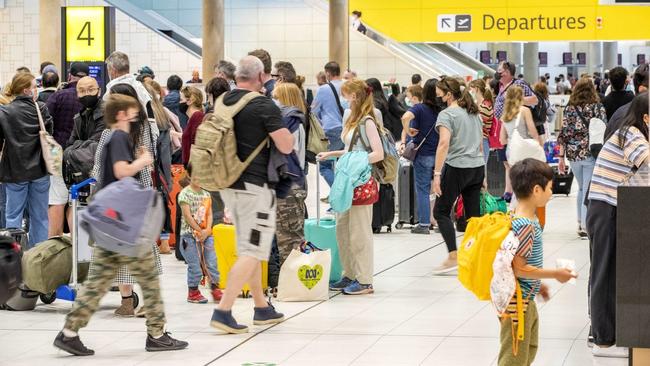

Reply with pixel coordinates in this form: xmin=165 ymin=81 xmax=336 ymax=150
xmin=329 ymin=0 xmax=350 ymax=72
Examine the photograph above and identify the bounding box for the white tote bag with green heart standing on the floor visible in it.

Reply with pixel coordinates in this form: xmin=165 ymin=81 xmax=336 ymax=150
xmin=278 ymin=242 xmax=332 ymax=301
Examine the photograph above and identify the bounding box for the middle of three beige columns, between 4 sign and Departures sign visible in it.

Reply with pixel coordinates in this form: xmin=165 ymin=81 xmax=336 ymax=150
xmin=201 ymin=0 xmax=226 ymax=83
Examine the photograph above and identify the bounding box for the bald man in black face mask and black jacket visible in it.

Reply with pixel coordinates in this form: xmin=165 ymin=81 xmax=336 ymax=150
xmin=63 ymin=76 xmax=106 ymax=200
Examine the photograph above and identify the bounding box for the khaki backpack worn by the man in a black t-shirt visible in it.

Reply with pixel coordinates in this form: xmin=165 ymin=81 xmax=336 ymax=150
xmin=190 ymin=92 xmax=269 ymax=192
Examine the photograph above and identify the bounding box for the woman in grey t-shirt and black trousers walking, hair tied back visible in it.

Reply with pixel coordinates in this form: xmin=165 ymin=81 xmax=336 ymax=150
xmin=432 ymin=77 xmax=485 ymax=274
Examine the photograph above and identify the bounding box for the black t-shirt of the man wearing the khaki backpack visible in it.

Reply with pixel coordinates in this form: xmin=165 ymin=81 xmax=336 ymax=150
xmin=224 ymin=89 xmax=286 ymax=189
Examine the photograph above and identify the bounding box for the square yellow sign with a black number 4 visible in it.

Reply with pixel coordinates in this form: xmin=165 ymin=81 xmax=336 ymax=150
xmin=65 ymin=6 xmax=106 ymax=62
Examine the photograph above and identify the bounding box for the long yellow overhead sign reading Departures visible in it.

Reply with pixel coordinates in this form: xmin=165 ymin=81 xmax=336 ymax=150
xmin=350 ymin=0 xmax=650 ymax=42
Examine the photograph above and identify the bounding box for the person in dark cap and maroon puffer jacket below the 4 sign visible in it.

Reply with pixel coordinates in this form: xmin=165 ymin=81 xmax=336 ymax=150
xmin=47 ymin=62 xmax=90 ymax=237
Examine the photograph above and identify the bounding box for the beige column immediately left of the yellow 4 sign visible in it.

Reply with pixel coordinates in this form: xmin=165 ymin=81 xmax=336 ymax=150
xmin=39 ymin=0 xmax=65 ymax=75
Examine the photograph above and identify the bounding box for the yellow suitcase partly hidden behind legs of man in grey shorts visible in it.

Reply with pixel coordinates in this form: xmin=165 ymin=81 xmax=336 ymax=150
xmin=212 ymin=224 xmax=269 ymax=297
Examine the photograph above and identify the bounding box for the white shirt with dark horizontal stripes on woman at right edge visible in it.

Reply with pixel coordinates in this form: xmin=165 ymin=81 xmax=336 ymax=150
xmin=589 ymin=127 xmax=650 ymax=206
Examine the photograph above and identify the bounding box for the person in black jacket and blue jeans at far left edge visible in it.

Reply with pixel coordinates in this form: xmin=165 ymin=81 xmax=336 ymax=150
xmin=0 ymin=73 xmax=53 ymax=249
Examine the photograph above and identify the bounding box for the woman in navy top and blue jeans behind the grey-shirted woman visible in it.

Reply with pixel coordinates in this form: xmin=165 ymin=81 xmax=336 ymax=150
xmin=402 ymin=79 xmax=440 ymax=234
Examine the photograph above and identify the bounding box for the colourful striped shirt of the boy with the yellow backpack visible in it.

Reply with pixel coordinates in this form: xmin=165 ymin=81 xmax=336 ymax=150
xmin=512 ymin=217 xmax=544 ymax=300
